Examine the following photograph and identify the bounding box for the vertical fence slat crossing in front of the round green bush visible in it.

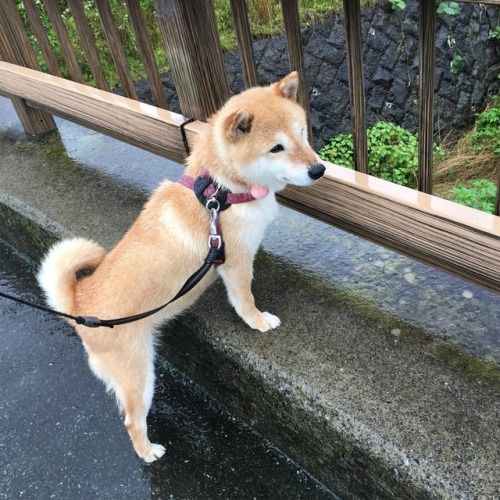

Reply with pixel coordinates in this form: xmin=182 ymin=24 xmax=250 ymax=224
xmin=344 ymin=0 xmax=368 ymax=174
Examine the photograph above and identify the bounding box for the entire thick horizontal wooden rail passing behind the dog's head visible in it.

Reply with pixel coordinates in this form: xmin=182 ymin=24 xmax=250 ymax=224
xmin=0 ymin=61 xmax=500 ymax=292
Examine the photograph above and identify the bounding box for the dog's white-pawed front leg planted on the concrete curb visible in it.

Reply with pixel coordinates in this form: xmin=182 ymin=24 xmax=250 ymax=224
xmin=218 ymin=256 xmax=281 ymax=332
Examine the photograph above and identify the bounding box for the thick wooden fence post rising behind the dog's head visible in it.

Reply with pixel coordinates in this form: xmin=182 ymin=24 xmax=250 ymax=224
xmin=155 ymin=0 xmax=229 ymax=120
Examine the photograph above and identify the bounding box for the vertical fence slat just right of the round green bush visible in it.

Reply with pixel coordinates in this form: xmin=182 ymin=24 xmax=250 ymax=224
xmin=418 ymin=0 xmax=436 ymax=194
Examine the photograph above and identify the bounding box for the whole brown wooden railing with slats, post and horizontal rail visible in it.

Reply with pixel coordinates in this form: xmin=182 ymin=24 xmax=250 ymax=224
xmin=0 ymin=0 xmax=500 ymax=291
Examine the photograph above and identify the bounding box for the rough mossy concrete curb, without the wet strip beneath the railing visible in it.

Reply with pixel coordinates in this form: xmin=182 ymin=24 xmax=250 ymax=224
xmin=0 ymin=97 xmax=500 ymax=499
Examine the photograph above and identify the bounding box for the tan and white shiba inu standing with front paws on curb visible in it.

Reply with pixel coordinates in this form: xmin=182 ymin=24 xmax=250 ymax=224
xmin=38 ymin=72 xmax=325 ymax=462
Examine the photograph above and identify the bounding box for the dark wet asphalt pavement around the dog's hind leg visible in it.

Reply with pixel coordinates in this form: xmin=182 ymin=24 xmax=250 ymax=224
xmin=0 ymin=243 xmax=336 ymax=499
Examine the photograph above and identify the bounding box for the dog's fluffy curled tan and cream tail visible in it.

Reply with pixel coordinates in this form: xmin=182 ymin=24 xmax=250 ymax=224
xmin=37 ymin=238 xmax=106 ymax=314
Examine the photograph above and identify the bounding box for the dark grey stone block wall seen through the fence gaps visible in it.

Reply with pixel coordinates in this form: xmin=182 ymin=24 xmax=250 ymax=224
xmin=135 ymin=0 xmax=500 ymax=147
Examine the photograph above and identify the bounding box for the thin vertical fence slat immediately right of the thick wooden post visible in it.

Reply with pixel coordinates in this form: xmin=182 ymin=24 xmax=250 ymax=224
xmin=231 ymin=0 xmax=259 ymax=88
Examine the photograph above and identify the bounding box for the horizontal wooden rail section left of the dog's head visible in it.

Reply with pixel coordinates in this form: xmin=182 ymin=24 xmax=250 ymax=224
xmin=0 ymin=61 xmax=201 ymax=162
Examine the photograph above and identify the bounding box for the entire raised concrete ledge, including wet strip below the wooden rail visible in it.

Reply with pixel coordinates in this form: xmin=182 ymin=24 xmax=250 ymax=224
xmin=0 ymin=95 xmax=500 ymax=499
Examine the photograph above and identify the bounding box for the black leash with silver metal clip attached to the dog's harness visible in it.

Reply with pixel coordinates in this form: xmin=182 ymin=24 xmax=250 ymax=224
xmin=0 ymin=201 xmax=224 ymax=328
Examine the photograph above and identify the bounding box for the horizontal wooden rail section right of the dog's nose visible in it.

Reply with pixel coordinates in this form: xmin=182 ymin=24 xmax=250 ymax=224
xmin=279 ymin=168 xmax=500 ymax=292
